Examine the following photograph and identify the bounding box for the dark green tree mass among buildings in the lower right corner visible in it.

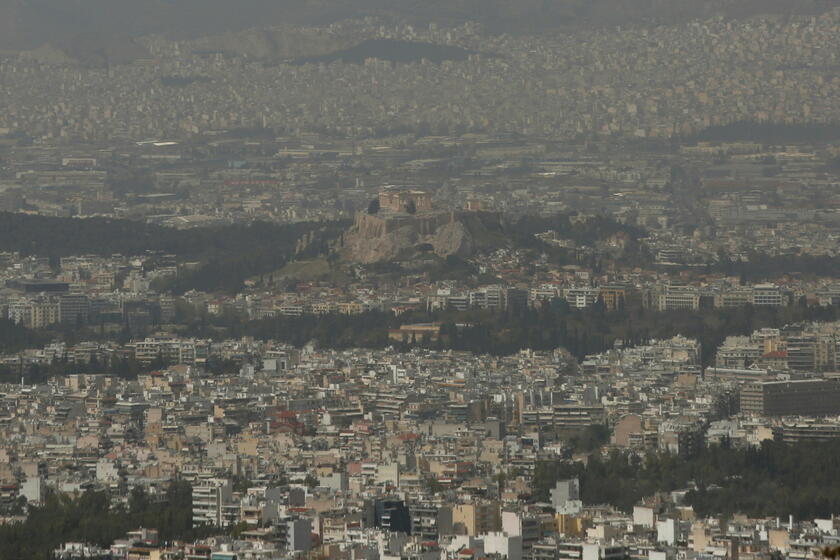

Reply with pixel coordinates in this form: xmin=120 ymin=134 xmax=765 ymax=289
xmin=532 ymin=440 xmax=840 ymax=519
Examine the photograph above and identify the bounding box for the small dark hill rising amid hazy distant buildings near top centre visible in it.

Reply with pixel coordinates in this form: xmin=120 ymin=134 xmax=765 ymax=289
xmin=293 ymin=39 xmax=470 ymax=64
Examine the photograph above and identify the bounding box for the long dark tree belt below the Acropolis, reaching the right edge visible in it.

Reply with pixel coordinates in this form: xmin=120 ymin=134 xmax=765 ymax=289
xmin=176 ymin=298 xmax=840 ymax=365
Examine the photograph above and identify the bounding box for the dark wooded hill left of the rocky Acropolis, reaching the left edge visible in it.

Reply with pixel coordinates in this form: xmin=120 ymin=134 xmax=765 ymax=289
xmin=0 ymin=212 xmax=347 ymax=293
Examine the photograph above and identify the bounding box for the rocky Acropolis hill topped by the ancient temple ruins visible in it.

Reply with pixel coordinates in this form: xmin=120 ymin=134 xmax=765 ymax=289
xmin=343 ymin=189 xmax=501 ymax=264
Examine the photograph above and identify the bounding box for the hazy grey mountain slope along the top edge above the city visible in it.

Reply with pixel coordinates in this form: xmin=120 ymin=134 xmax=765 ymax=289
xmin=0 ymin=0 xmax=840 ymax=49
